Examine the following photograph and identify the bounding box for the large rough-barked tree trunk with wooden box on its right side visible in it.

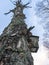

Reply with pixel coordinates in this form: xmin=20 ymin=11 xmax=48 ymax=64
xmin=0 ymin=0 xmax=39 ymax=65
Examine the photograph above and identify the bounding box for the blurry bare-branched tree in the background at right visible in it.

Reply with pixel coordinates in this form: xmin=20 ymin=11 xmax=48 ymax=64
xmin=36 ymin=0 xmax=49 ymax=48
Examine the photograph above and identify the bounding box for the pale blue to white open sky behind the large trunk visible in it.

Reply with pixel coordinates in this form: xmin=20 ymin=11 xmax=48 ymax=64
xmin=0 ymin=0 xmax=49 ymax=65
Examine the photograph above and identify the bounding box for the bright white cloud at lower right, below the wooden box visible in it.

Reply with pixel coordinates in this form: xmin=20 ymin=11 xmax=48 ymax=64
xmin=32 ymin=45 xmax=49 ymax=65
